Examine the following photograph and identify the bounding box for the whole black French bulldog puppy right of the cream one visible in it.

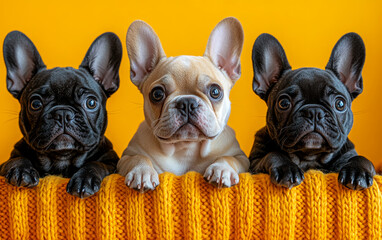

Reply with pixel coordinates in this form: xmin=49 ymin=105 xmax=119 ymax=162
xmin=249 ymin=33 xmax=375 ymax=190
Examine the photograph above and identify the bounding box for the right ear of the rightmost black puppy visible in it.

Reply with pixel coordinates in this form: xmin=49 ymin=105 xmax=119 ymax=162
xmin=326 ymin=33 xmax=365 ymax=99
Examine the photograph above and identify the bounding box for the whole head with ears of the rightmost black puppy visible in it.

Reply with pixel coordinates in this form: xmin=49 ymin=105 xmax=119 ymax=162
xmin=253 ymin=33 xmax=365 ymax=155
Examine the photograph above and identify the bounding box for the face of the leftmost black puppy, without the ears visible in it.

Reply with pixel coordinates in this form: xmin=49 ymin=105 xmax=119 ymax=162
xmin=20 ymin=68 xmax=107 ymax=151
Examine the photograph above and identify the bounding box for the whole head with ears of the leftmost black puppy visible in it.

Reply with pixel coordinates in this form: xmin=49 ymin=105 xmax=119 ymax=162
xmin=4 ymin=32 xmax=122 ymax=154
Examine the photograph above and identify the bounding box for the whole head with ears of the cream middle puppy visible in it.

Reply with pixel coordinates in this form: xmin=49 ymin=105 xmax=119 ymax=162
xmin=127 ymin=18 xmax=243 ymax=143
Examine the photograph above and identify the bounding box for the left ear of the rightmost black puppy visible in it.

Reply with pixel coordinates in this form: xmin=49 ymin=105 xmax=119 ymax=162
xmin=252 ymin=33 xmax=291 ymax=100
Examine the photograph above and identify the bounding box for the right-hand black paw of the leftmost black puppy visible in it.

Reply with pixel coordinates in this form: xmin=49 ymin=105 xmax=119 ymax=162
xmin=66 ymin=169 xmax=102 ymax=198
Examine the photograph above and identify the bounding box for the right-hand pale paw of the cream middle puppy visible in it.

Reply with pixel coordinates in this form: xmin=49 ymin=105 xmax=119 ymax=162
xmin=204 ymin=162 xmax=239 ymax=188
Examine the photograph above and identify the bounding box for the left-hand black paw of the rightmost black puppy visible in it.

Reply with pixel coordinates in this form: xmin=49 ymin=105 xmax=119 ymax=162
xmin=270 ymin=163 xmax=305 ymax=189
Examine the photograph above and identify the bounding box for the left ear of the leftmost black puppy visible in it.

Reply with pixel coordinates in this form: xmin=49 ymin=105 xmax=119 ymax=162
xmin=3 ymin=31 xmax=46 ymax=99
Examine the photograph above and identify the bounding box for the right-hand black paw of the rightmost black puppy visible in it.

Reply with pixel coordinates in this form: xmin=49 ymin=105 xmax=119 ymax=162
xmin=338 ymin=165 xmax=373 ymax=190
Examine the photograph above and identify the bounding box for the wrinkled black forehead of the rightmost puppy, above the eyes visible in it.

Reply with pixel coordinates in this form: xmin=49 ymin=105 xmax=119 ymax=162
xmin=272 ymin=68 xmax=351 ymax=102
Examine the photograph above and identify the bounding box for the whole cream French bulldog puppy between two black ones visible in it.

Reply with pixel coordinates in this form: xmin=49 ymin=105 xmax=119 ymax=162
xmin=117 ymin=18 xmax=249 ymax=192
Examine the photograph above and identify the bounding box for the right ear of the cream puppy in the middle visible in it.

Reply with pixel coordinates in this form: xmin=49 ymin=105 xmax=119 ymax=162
xmin=204 ymin=17 xmax=244 ymax=83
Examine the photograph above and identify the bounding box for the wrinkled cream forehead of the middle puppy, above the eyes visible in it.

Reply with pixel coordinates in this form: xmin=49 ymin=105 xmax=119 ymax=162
xmin=143 ymin=56 xmax=231 ymax=94
